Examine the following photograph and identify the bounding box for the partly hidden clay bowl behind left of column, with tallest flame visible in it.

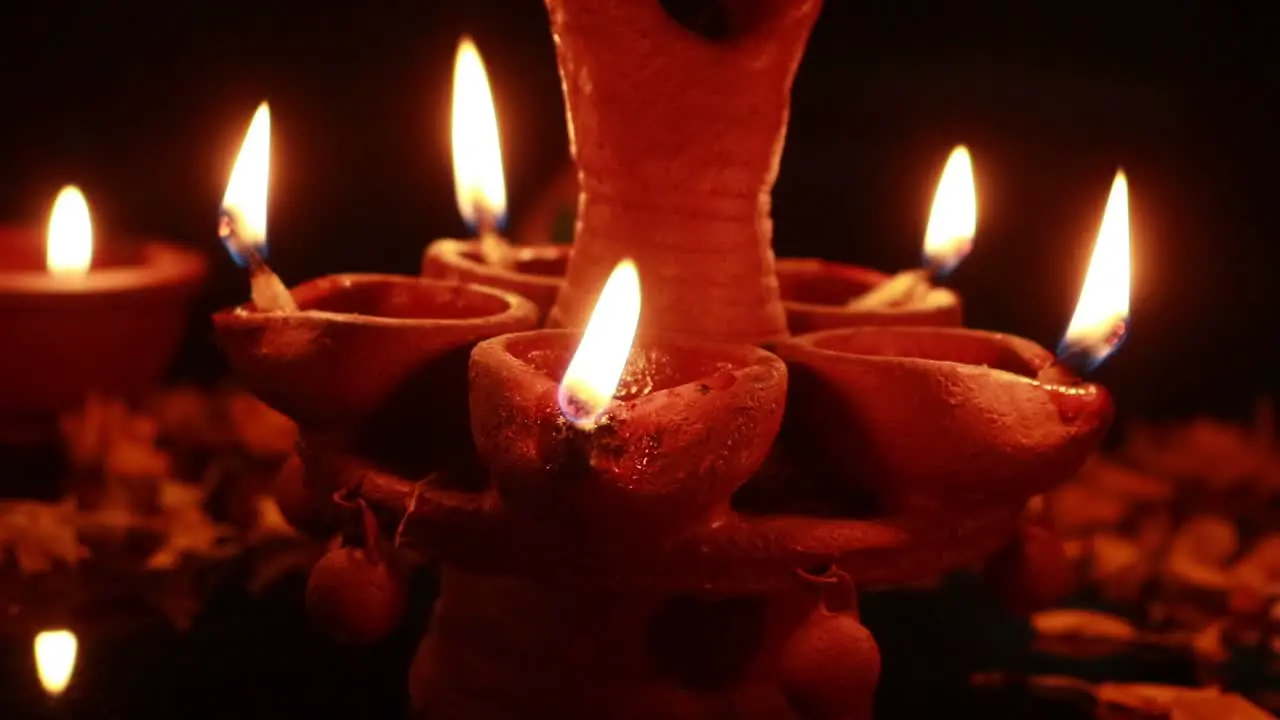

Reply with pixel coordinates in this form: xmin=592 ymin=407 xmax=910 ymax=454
xmin=422 ymin=37 xmax=568 ymax=316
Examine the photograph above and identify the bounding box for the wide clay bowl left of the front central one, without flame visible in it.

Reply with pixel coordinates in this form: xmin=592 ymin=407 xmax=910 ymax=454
xmin=214 ymin=274 xmax=538 ymax=432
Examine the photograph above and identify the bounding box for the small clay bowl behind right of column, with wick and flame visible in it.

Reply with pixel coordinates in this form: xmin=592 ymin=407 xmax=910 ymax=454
xmin=778 ymin=145 xmax=978 ymax=334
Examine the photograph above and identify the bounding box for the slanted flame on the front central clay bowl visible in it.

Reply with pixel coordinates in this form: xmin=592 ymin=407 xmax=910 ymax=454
xmin=559 ymin=260 xmax=640 ymax=429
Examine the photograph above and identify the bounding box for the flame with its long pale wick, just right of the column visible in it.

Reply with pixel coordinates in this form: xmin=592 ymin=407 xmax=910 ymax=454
xmin=849 ymin=145 xmax=978 ymax=309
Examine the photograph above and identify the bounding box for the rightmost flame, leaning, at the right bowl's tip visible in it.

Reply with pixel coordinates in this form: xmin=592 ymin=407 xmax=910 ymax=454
xmin=1059 ymin=170 xmax=1130 ymax=368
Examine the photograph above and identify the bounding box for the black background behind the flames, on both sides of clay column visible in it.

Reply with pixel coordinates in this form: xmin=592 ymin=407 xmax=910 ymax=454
xmin=0 ymin=0 xmax=1280 ymax=415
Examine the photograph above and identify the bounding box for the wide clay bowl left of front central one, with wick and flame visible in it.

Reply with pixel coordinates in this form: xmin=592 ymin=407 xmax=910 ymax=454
xmin=214 ymin=104 xmax=538 ymax=532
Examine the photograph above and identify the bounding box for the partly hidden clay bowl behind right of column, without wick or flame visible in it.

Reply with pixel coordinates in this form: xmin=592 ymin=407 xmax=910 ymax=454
xmin=778 ymin=258 xmax=964 ymax=336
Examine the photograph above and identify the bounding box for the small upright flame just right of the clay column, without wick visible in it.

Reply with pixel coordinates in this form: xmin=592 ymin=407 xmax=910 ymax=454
xmin=924 ymin=145 xmax=978 ymax=275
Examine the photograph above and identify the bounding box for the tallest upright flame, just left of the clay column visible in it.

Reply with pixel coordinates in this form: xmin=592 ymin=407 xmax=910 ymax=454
xmin=452 ymin=36 xmax=507 ymax=232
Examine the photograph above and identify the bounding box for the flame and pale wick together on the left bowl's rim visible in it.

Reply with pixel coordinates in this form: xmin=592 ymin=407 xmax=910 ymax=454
xmin=218 ymin=101 xmax=298 ymax=313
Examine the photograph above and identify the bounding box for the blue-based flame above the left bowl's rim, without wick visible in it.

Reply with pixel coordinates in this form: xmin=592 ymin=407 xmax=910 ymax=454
xmin=218 ymin=101 xmax=271 ymax=265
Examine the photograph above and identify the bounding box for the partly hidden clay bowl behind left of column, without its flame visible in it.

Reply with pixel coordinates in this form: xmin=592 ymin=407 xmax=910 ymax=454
xmin=422 ymin=238 xmax=571 ymax=324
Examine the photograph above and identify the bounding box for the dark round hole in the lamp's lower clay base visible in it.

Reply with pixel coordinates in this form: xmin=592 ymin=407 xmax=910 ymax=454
xmin=648 ymin=596 xmax=767 ymax=692
